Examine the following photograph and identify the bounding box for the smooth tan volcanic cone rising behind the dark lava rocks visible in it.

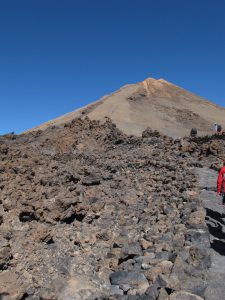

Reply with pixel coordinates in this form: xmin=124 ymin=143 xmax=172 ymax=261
xmin=27 ymin=78 xmax=225 ymax=137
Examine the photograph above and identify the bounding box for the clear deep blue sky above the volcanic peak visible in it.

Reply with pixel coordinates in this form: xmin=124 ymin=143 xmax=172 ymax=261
xmin=0 ymin=0 xmax=225 ymax=134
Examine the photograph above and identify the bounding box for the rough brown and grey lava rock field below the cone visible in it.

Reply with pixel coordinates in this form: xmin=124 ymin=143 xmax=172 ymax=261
xmin=0 ymin=119 xmax=225 ymax=300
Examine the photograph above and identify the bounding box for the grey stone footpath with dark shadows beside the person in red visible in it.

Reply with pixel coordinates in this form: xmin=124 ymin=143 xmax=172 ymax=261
xmin=196 ymin=168 xmax=225 ymax=300
